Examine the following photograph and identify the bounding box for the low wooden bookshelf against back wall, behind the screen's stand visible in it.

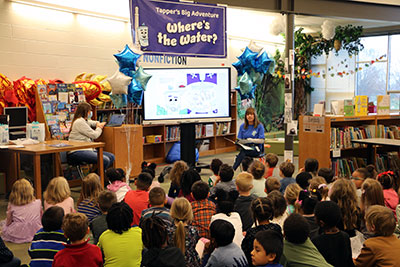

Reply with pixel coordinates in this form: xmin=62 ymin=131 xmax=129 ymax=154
xmin=139 ymin=91 xmax=237 ymax=163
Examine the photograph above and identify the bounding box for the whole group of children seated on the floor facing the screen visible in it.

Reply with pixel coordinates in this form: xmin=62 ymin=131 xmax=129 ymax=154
xmin=0 ymin=154 xmax=400 ymax=267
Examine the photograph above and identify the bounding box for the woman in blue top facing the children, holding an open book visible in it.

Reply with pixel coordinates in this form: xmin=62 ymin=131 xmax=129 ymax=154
xmin=233 ymin=108 xmax=265 ymax=170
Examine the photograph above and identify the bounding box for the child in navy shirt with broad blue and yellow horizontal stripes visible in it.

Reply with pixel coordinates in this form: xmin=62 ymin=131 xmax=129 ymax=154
xmin=28 ymin=206 xmax=67 ymax=267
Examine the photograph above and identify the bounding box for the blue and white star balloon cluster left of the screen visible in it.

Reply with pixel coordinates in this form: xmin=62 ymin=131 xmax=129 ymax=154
xmin=109 ymin=45 xmax=151 ymax=108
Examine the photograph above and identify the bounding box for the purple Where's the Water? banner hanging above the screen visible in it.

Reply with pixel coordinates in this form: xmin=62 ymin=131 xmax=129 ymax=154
xmin=130 ymin=0 xmax=227 ymax=58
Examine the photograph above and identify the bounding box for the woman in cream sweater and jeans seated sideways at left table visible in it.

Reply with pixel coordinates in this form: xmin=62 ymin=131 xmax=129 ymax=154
xmin=68 ymin=102 xmax=115 ymax=169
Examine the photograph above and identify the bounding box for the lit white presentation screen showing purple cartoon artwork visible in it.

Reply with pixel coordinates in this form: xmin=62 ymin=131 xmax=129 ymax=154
xmin=144 ymin=67 xmax=230 ymax=123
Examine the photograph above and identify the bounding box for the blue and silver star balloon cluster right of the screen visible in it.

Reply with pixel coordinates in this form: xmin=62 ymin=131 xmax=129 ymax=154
xmin=232 ymin=47 xmax=274 ymax=101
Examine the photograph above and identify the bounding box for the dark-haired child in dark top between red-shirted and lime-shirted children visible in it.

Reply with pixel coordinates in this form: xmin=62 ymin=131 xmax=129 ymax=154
xmin=89 ymin=190 xmax=117 ymax=245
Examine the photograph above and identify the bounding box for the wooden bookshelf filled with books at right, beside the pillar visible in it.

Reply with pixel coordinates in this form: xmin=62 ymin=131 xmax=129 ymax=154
xmin=299 ymin=114 xmax=400 ymax=177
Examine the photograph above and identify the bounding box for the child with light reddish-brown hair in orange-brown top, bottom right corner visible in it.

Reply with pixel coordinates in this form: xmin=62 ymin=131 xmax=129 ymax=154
xmin=354 ymin=205 xmax=400 ymax=266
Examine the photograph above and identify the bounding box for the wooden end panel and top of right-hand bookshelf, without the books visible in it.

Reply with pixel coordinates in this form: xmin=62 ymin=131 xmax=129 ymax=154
xmin=299 ymin=114 xmax=400 ymax=172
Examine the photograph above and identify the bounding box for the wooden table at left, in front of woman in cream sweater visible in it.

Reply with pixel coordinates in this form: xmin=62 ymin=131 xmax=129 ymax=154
xmin=8 ymin=140 xmax=105 ymax=199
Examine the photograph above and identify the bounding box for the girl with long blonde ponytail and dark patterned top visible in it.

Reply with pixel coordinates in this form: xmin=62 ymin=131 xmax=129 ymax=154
xmin=168 ymin=197 xmax=200 ymax=267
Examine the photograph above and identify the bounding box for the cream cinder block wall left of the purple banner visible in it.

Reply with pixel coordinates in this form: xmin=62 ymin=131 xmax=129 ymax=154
xmin=0 ymin=0 xmax=132 ymax=82
